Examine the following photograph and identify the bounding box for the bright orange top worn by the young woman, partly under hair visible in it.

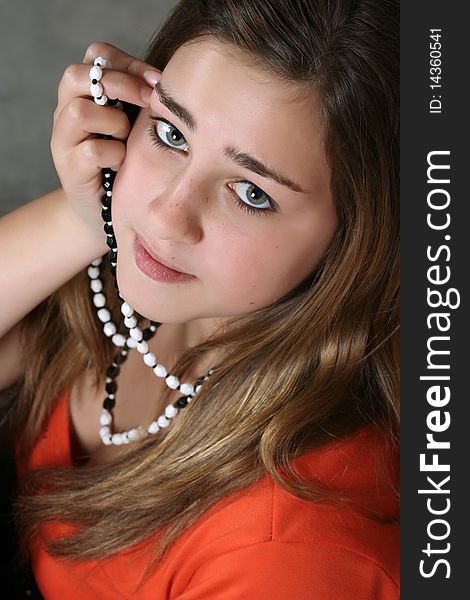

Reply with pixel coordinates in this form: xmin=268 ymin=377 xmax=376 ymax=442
xmin=20 ymin=394 xmax=399 ymax=600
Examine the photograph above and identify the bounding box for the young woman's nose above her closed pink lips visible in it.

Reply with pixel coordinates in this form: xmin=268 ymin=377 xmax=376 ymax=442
xmin=148 ymin=179 xmax=203 ymax=244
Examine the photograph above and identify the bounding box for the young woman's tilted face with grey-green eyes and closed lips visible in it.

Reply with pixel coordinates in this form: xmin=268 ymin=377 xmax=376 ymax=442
xmin=113 ymin=40 xmax=337 ymax=323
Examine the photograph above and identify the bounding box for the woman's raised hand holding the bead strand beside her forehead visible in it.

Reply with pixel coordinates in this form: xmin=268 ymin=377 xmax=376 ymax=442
xmin=51 ymin=42 xmax=161 ymax=251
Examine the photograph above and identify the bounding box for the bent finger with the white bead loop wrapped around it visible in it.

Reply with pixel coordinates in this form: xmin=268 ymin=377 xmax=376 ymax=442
xmin=58 ymin=64 xmax=156 ymax=112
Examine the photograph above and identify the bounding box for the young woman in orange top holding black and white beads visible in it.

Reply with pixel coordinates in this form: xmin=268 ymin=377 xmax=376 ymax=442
xmin=0 ymin=0 xmax=399 ymax=600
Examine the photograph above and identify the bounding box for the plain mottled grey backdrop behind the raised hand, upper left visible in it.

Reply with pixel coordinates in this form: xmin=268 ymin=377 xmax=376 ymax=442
xmin=0 ymin=0 xmax=176 ymax=216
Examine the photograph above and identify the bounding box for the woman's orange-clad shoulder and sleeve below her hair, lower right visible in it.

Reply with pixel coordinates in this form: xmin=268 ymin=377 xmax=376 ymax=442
xmin=162 ymin=424 xmax=399 ymax=600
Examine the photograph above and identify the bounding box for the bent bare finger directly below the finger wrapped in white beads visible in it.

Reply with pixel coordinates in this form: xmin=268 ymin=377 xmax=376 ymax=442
xmin=51 ymin=98 xmax=131 ymax=154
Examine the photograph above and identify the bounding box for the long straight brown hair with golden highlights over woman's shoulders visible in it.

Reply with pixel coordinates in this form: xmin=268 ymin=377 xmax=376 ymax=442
xmin=11 ymin=0 xmax=399 ymax=572
